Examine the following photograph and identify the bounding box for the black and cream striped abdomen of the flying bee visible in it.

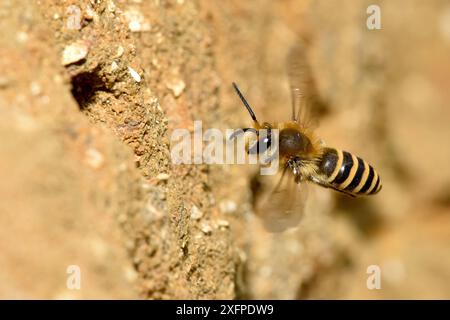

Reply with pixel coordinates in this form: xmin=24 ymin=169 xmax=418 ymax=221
xmin=319 ymin=148 xmax=381 ymax=195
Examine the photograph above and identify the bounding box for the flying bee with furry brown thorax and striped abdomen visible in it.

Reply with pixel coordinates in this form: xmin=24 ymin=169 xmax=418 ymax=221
xmin=231 ymin=46 xmax=382 ymax=230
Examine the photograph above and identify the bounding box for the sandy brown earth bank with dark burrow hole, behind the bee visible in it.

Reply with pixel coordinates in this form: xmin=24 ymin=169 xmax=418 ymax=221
xmin=0 ymin=0 xmax=450 ymax=299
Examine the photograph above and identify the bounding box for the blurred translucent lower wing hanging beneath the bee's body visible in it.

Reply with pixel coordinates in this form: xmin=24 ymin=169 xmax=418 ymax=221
xmin=255 ymin=169 xmax=307 ymax=232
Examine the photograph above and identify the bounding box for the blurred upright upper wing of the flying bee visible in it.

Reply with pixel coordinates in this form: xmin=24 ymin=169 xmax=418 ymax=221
xmin=286 ymin=42 xmax=315 ymax=124
